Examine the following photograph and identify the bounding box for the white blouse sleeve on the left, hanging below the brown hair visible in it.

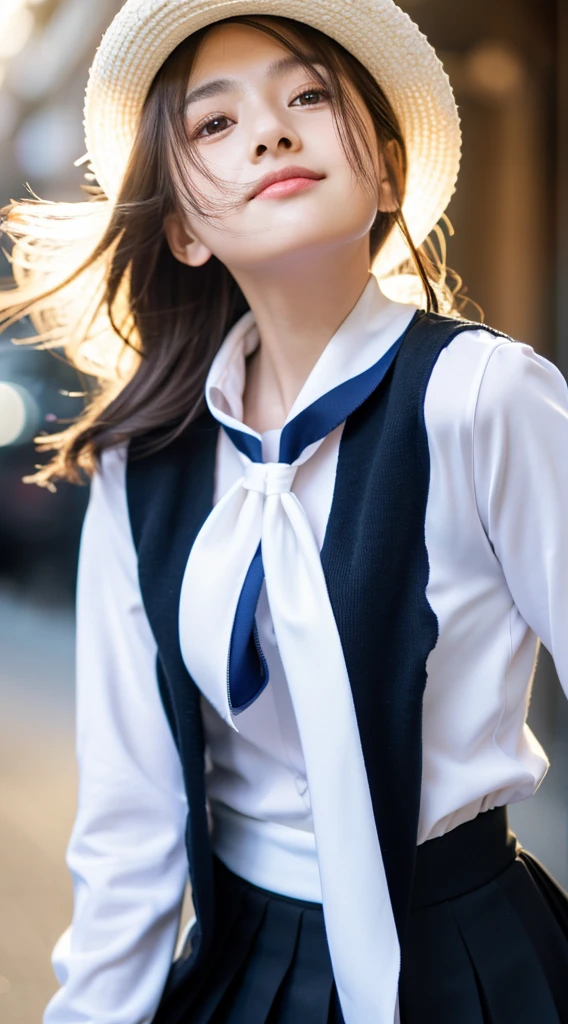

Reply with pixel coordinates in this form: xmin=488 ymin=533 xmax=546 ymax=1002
xmin=44 ymin=447 xmax=187 ymax=1024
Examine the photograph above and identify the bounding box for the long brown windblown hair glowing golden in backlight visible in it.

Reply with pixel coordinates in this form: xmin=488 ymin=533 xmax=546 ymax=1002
xmin=0 ymin=17 xmax=464 ymax=489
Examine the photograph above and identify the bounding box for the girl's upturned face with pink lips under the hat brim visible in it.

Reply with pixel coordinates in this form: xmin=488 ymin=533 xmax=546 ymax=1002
xmin=167 ymin=24 xmax=388 ymax=271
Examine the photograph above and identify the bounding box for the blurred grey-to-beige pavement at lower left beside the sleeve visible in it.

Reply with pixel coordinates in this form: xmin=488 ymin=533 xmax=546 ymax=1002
xmin=0 ymin=590 xmax=76 ymax=1024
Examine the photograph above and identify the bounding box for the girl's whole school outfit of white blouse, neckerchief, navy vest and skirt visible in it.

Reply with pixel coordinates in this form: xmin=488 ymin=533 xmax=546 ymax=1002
xmin=44 ymin=278 xmax=568 ymax=1024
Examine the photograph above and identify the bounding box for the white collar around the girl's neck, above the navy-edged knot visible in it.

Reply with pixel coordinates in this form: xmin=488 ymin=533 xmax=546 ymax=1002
xmin=205 ymin=274 xmax=417 ymax=437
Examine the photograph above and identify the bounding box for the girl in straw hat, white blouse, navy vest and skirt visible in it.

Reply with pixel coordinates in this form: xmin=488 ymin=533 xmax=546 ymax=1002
xmin=3 ymin=0 xmax=568 ymax=1024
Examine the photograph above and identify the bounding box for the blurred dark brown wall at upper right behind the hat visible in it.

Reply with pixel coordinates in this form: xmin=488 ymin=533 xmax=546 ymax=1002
xmin=401 ymin=0 xmax=559 ymax=357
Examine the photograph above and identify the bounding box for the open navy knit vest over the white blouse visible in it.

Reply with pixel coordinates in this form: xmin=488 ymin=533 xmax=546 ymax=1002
xmin=127 ymin=311 xmax=505 ymax=1021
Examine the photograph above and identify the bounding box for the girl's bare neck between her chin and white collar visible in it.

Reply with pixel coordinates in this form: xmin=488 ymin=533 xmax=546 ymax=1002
xmin=234 ymin=240 xmax=369 ymax=433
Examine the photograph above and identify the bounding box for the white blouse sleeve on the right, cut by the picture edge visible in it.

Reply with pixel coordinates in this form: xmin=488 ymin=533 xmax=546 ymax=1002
xmin=474 ymin=342 xmax=568 ymax=693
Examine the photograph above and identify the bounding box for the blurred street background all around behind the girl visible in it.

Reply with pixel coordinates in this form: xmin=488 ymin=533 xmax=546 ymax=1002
xmin=0 ymin=0 xmax=568 ymax=1024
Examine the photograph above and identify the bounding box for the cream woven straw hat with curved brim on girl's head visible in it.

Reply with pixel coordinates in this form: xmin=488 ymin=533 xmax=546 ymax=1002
xmin=83 ymin=0 xmax=461 ymax=278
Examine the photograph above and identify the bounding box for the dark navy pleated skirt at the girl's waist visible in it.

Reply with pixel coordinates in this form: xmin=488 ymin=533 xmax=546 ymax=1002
xmin=156 ymin=807 xmax=568 ymax=1024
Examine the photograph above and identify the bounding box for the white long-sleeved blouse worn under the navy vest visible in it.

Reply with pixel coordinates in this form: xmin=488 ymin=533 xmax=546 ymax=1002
xmin=44 ymin=279 xmax=568 ymax=1024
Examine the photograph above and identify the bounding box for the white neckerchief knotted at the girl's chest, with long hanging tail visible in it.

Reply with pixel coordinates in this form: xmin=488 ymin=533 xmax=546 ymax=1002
xmin=179 ymin=278 xmax=414 ymax=1024
